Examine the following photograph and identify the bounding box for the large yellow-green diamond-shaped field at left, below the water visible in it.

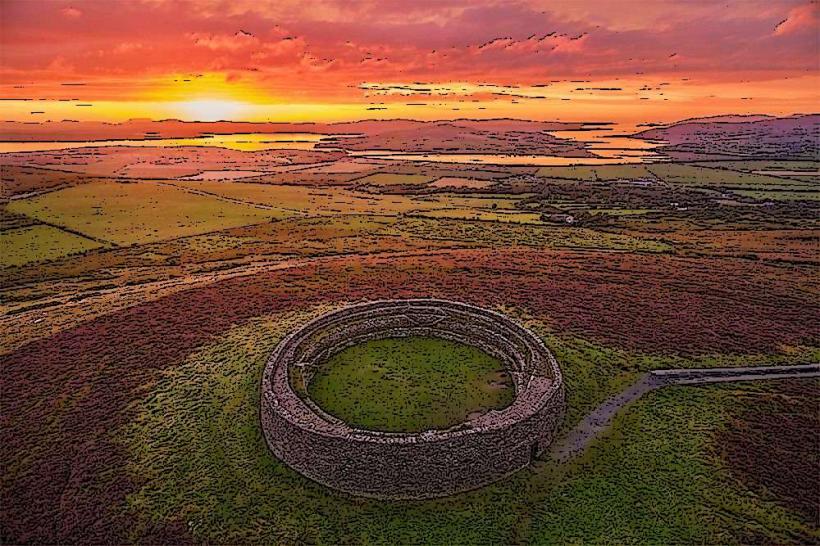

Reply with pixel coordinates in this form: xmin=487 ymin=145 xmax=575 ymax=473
xmin=8 ymin=182 xmax=282 ymax=245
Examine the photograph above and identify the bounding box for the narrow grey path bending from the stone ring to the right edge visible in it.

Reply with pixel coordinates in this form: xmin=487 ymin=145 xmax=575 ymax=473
xmin=550 ymin=364 xmax=820 ymax=462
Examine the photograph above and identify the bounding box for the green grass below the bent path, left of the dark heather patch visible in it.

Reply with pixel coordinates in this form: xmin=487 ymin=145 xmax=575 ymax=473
xmin=525 ymin=383 xmax=820 ymax=544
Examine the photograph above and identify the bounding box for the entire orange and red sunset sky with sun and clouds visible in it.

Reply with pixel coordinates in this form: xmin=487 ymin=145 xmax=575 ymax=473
xmin=0 ymin=0 xmax=820 ymax=123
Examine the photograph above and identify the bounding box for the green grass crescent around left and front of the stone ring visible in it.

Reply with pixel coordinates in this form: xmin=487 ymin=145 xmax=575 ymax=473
xmin=115 ymin=307 xmax=532 ymax=544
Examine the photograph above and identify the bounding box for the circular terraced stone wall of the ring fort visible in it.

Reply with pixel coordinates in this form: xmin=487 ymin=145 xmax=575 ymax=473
xmin=261 ymin=299 xmax=564 ymax=498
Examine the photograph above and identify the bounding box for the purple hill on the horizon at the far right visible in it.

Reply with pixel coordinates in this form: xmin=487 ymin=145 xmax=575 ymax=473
xmin=633 ymin=114 xmax=820 ymax=160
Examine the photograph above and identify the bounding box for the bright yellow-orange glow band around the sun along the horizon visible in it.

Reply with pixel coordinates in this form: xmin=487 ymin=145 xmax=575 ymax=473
xmin=0 ymin=73 xmax=820 ymax=125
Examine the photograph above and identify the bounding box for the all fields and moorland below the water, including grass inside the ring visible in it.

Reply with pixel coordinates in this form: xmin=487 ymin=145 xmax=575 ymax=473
xmin=0 ymin=141 xmax=820 ymax=544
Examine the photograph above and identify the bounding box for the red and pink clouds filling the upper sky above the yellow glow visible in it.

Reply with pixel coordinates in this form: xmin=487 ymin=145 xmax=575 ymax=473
xmin=0 ymin=0 xmax=818 ymax=106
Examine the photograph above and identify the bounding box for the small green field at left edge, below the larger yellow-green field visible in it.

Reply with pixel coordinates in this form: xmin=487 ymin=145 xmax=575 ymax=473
xmin=0 ymin=224 xmax=103 ymax=267
